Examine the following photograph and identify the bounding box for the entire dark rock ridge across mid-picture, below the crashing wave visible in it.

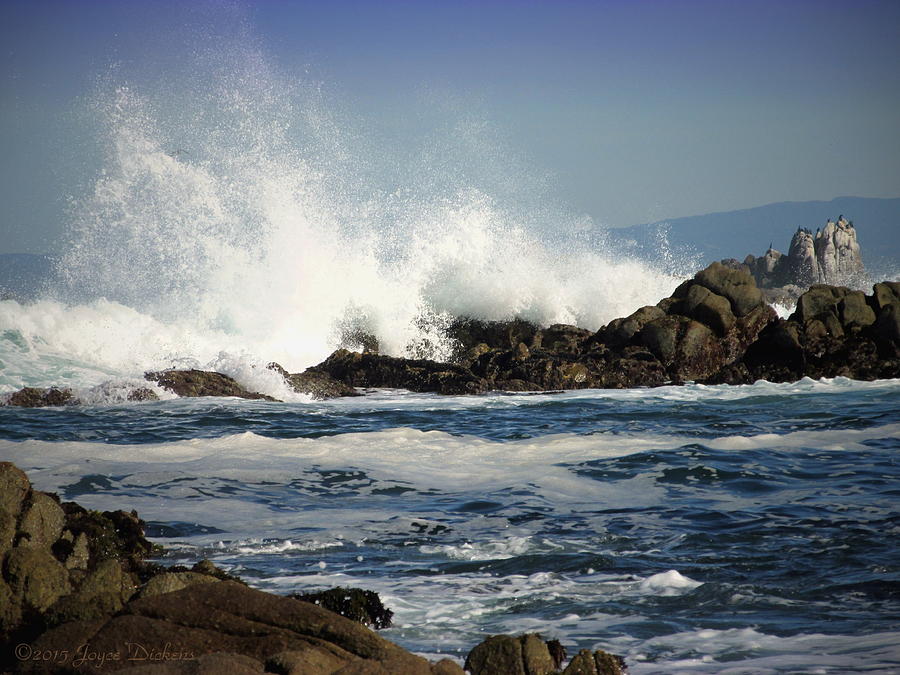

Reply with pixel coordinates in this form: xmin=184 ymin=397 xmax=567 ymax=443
xmin=6 ymin=263 xmax=900 ymax=407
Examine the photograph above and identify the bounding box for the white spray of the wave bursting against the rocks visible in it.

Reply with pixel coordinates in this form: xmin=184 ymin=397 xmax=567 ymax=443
xmin=5 ymin=21 xmax=678 ymax=390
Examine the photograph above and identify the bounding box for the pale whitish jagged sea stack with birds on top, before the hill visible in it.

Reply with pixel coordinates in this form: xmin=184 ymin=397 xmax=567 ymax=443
xmin=722 ymin=215 xmax=866 ymax=300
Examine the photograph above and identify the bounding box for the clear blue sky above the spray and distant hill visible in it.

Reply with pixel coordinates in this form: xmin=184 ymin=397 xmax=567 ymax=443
xmin=0 ymin=0 xmax=900 ymax=252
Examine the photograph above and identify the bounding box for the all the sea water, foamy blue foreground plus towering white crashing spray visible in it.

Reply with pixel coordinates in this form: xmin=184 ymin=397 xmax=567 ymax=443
xmin=0 ymin=18 xmax=900 ymax=675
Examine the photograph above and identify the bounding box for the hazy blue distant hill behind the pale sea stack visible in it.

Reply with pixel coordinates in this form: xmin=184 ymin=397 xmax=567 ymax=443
xmin=608 ymin=197 xmax=900 ymax=278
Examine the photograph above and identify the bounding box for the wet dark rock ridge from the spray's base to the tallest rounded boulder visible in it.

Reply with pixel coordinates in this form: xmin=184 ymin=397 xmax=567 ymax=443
xmin=311 ymin=263 xmax=775 ymax=394
